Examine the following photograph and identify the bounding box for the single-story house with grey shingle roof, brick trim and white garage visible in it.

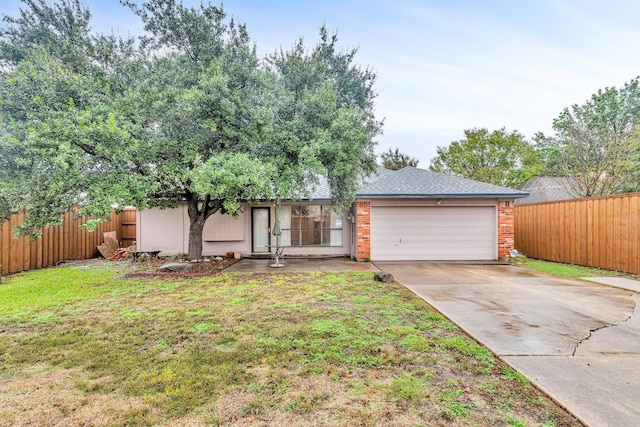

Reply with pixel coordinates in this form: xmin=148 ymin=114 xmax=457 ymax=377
xmin=137 ymin=167 xmax=528 ymax=261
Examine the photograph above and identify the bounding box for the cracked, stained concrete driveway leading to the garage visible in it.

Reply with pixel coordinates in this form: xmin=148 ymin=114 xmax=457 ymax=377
xmin=376 ymin=263 xmax=640 ymax=426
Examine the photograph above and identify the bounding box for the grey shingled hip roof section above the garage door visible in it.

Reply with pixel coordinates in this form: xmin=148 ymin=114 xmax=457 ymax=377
xmin=356 ymin=166 xmax=528 ymax=199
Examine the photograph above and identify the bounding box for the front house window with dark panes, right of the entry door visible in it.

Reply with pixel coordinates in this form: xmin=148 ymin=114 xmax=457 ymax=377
xmin=280 ymin=205 xmax=342 ymax=246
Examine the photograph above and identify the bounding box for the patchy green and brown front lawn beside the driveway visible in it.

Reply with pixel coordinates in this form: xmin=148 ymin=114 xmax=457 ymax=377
xmin=0 ymin=262 xmax=579 ymax=426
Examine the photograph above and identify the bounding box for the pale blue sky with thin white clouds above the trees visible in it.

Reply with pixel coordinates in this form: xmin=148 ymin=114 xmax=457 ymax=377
xmin=0 ymin=0 xmax=640 ymax=168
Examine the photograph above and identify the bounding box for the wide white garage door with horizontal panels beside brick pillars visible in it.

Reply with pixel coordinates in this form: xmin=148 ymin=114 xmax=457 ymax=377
xmin=371 ymin=206 xmax=497 ymax=261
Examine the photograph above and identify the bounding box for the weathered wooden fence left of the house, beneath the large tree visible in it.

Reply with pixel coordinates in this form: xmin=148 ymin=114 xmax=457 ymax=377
xmin=0 ymin=209 xmax=136 ymax=274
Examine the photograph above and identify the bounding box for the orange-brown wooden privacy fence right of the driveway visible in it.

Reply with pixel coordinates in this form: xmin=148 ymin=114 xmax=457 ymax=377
xmin=515 ymin=193 xmax=640 ymax=274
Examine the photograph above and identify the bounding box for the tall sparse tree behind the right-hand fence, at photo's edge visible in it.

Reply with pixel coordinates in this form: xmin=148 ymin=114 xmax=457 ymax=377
xmin=546 ymin=79 xmax=640 ymax=197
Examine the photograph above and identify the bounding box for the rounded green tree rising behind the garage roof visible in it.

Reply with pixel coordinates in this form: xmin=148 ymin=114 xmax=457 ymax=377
xmin=429 ymin=128 xmax=542 ymax=187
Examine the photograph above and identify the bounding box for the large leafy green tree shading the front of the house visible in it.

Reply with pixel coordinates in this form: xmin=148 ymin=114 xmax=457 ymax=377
xmin=0 ymin=0 xmax=381 ymax=259
